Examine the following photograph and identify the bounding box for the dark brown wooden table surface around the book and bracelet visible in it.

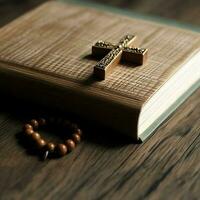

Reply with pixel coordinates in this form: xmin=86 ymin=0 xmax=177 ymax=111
xmin=0 ymin=0 xmax=200 ymax=200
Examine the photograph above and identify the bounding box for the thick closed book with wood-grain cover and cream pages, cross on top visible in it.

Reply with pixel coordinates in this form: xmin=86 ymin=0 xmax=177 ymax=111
xmin=0 ymin=2 xmax=200 ymax=141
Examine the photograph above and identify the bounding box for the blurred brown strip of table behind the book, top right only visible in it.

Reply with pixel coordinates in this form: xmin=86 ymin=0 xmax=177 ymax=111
xmin=92 ymin=0 xmax=200 ymax=25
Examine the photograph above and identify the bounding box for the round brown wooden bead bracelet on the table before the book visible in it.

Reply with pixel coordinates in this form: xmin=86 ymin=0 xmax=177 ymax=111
xmin=23 ymin=118 xmax=82 ymax=160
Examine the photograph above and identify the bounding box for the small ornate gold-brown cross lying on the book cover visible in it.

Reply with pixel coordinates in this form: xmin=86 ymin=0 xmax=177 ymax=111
xmin=92 ymin=35 xmax=148 ymax=80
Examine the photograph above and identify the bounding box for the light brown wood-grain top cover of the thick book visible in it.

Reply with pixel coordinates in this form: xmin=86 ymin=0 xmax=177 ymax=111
xmin=0 ymin=2 xmax=200 ymax=105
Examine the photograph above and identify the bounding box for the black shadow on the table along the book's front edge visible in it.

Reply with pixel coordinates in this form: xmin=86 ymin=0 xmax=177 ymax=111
xmin=0 ymin=95 xmax=138 ymax=153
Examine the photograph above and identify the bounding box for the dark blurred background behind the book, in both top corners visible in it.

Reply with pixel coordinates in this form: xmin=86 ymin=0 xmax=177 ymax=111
xmin=0 ymin=0 xmax=200 ymax=25
